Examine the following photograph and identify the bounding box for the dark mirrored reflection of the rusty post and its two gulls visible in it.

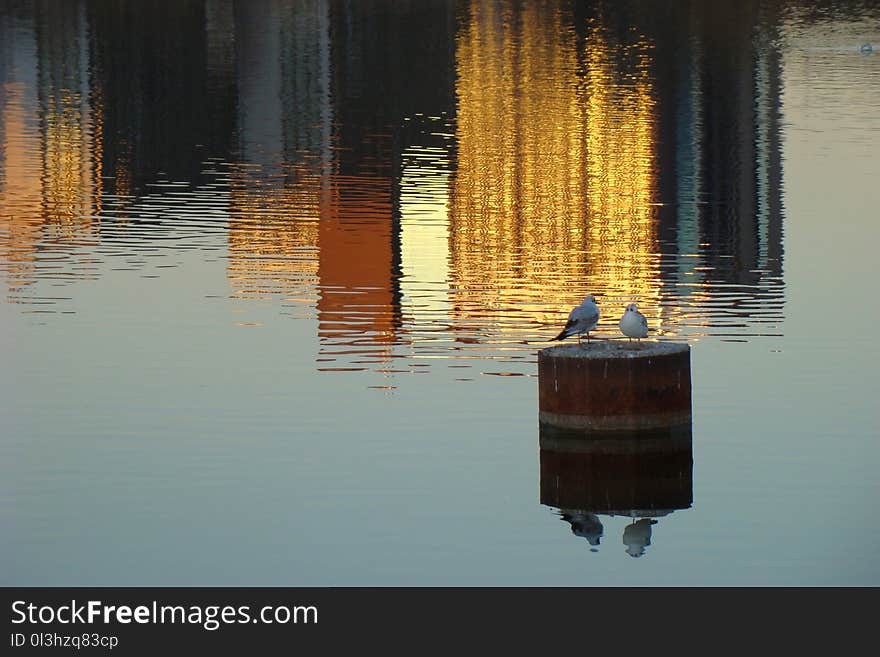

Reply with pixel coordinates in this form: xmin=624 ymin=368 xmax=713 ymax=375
xmin=539 ymin=423 xmax=693 ymax=557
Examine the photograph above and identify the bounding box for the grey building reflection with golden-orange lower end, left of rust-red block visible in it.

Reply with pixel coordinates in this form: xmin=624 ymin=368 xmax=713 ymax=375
xmin=223 ymin=1 xmax=333 ymax=303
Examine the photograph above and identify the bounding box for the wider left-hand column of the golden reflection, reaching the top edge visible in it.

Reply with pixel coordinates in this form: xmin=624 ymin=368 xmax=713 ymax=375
xmin=449 ymin=1 xmax=589 ymax=338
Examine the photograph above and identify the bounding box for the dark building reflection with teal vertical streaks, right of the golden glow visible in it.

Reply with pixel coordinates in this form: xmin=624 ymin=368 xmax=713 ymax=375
xmin=657 ymin=2 xmax=782 ymax=285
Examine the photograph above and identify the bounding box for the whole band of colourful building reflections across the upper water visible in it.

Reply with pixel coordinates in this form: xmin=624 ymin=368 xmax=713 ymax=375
xmin=0 ymin=0 xmax=783 ymax=378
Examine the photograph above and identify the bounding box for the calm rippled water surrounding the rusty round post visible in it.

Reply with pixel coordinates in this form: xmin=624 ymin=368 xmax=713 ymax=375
xmin=0 ymin=0 xmax=880 ymax=586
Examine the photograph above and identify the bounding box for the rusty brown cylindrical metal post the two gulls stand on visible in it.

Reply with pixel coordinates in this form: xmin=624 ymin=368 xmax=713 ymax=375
xmin=538 ymin=340 xmax=691 ymax=433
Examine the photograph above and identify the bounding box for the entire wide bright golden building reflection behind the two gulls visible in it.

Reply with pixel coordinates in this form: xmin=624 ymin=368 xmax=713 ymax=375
xmin=450 ymin=0 xmax=661 ymax=337
